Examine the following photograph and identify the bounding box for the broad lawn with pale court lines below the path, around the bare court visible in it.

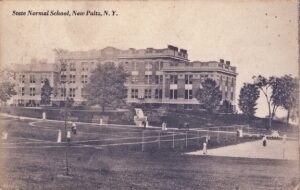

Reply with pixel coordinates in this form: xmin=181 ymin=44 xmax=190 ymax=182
xmin=0 ymin=117 xmax=297 ymax=190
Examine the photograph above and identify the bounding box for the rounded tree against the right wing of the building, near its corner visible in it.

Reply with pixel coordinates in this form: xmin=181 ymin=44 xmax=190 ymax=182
xmin=196 ymin=79 xmax=222 ymax=113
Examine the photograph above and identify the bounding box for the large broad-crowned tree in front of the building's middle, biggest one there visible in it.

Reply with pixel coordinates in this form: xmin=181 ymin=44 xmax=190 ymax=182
xmin=84 ymin=63 xmax=127 ymax=112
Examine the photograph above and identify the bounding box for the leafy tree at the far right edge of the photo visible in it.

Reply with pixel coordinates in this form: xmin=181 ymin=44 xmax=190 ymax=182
xmin=271 ymin=75 xmax=298 ymax=126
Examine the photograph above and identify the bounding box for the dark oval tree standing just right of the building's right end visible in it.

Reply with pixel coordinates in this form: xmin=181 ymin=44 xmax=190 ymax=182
xmin=238 ymin=83 xmax=259 ymax=119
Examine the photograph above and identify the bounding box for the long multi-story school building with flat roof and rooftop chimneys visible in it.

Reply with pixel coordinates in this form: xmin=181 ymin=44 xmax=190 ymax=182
xmin=14 ymin=46 xmax=237 ymax=109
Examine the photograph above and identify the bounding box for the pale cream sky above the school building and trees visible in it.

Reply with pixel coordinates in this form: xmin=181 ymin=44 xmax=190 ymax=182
xmin=0 ymin=0 xmax=298 ymax=119
